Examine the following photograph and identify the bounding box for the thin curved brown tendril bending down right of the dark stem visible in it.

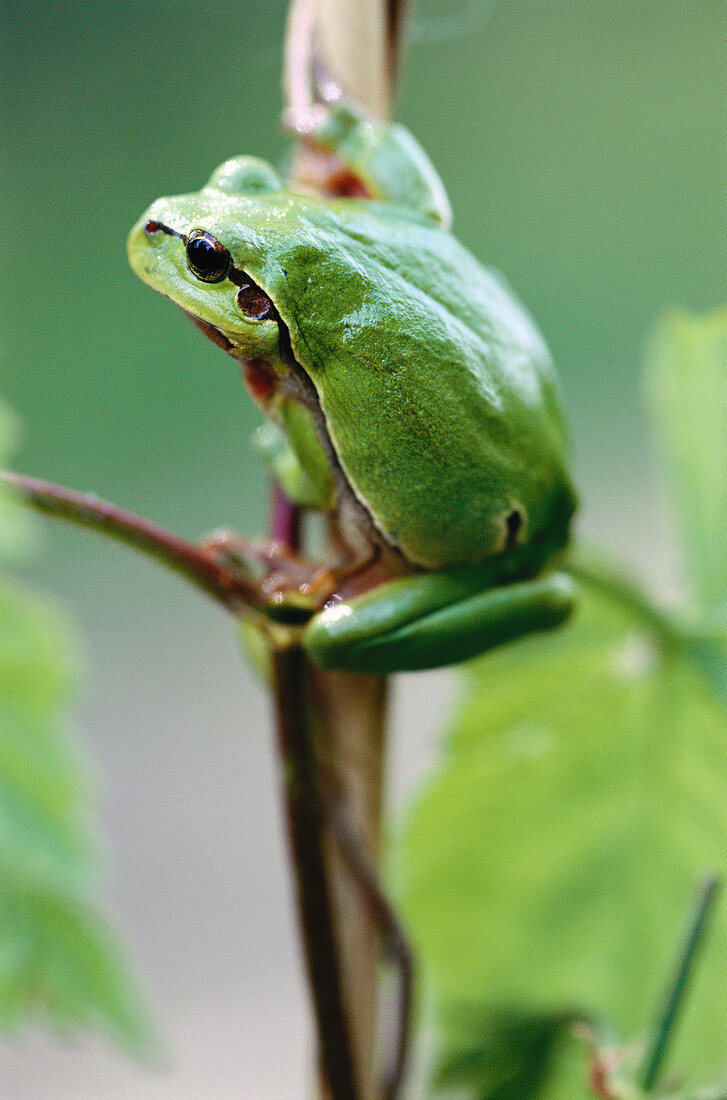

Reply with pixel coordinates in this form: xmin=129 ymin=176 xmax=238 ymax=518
xmin=326 ymin=794 xmax=414 ymax=1100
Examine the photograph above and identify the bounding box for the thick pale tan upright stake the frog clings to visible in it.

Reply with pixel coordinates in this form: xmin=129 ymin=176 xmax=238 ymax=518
xmin=280 ymin=0 xmax=411 ymax=1100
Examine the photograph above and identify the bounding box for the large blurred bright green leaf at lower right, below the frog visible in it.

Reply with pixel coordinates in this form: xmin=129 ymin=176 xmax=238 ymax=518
xmin=397 ymin=589 xmax=727 ymax=1100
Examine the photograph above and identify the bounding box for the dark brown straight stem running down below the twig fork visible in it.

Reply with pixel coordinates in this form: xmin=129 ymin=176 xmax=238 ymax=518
xmin=272 ymin=647 xmax=359 ymax=1100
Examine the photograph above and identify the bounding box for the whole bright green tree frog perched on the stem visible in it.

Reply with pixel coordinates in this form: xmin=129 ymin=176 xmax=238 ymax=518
xmin=129 ymin=105 xmax=574 ymax=672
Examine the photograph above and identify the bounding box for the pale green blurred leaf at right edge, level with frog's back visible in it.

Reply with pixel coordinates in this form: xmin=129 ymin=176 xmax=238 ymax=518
xmin=646 ymin=309 xmax=727 ymax=605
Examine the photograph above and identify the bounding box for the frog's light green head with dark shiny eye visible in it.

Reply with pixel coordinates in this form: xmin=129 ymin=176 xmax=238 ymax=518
xmin=129 ymin=156 xmax=287 ymax=362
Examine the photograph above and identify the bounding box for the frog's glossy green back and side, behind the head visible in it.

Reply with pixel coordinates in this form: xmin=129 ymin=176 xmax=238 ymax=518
xmin=258 ymin=200 xmax=574 ymax=567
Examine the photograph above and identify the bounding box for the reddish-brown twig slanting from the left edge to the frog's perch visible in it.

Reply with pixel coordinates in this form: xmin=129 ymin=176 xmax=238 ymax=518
xmin=0 ymin=473 xmax=263 ymax=614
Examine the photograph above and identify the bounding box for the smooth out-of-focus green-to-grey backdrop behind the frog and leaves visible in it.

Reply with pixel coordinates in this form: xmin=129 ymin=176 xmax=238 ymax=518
xmin=0 ymin=0 xmax=727 ymax=1100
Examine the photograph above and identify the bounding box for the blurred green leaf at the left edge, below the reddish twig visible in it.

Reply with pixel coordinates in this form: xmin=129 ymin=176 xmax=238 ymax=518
xmin=0 ymin=409 xmax=148 ymax=1051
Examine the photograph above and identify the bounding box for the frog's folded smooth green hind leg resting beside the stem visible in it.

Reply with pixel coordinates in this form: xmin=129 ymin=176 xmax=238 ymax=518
xmin=302 ymin=570 xmax=575 ymax=672
